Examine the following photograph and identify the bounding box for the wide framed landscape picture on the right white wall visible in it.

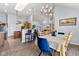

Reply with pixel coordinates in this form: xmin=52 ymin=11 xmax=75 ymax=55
xmin=59 ymin=17 xmax=77 ymax=26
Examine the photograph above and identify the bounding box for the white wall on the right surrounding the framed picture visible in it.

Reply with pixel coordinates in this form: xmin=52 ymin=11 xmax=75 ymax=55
xmin=55 ymin=6 xmax=79 ymax=45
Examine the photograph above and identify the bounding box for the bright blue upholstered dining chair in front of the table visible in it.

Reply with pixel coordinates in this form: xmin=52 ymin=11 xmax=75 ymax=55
xmin=37 ymin=37 xmax=54 ymax=56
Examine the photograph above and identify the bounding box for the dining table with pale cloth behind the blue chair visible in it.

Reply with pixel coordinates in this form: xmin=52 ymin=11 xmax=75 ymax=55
xmin=35 ymin=34 xmax=65 ymax=52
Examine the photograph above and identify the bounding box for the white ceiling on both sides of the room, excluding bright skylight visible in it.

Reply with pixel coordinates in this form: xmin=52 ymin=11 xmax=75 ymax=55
xmin=0 ymin=3 xmax=79 ymax=17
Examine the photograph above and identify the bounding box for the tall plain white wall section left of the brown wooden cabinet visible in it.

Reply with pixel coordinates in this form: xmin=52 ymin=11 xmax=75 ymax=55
xmin=8 ymin=14 xmax=16 ymax=36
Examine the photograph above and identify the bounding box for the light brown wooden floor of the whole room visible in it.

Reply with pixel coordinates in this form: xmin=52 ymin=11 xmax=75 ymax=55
xmin=0 ymin=38 xmax=79 ymax=56
